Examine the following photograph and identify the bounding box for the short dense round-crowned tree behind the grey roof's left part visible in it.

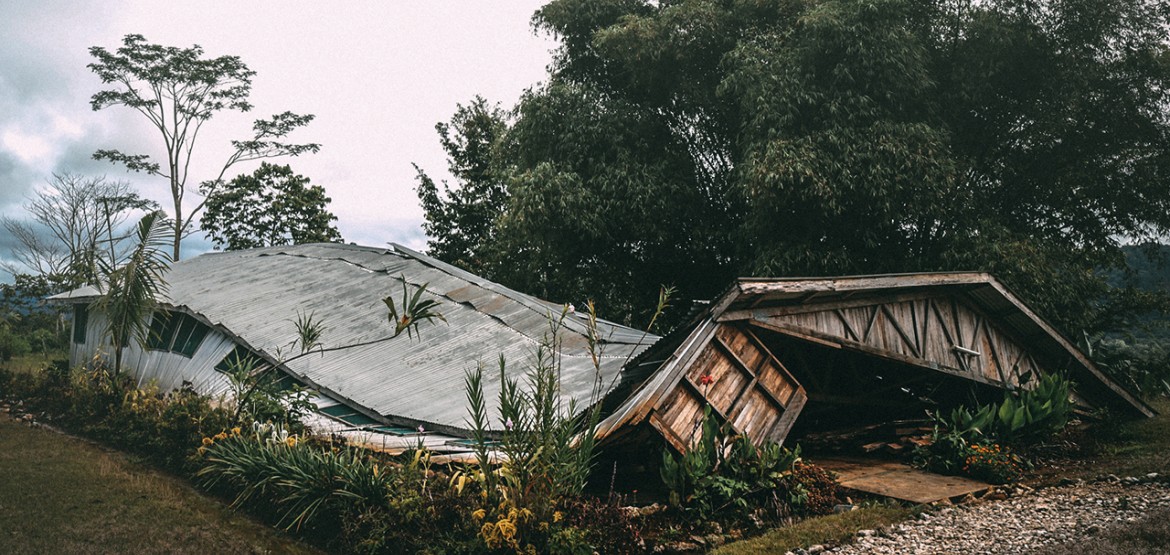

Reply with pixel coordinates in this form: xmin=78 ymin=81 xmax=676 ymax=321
xmin=201 ymin=163 xmax=342 ymax=251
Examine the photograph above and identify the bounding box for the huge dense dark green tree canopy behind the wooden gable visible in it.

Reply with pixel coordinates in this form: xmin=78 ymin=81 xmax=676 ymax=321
xmin=424 ymin=0 xmax=1170 ymax=330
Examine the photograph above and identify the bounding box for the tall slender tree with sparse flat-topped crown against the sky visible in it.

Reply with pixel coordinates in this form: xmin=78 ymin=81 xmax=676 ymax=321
xmin=88 ymin=35 xmax=321 ymax=260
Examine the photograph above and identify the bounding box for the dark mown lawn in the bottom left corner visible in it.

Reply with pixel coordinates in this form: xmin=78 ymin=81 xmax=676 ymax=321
xmin=0 ymin=413 xmax=318 ymax=555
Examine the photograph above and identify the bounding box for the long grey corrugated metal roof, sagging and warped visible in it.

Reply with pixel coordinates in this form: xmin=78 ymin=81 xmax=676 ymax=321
xmin=57 ymin=244 xmax=658 ymax=431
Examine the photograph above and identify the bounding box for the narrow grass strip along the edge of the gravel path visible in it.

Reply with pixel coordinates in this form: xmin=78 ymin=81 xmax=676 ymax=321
xmin=713 ymin=506 xmax=916 ymax=555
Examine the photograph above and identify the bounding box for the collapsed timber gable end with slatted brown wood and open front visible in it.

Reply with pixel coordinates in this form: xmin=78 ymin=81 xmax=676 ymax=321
xmin=598 ymin=273 xmax=1154 ymax=451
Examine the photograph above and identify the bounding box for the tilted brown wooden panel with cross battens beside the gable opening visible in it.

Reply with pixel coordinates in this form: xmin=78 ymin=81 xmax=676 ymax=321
xmin=651 ymin=324 xmax=807 ymax=451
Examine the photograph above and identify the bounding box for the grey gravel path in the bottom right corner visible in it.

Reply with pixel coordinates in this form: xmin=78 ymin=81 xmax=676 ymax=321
xmin=814 ymin=474 xmax=1170 ymax=555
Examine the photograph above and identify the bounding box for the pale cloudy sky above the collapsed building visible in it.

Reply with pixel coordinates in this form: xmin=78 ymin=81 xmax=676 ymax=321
xmin=0 ymin=0 xmax=556 ymax=281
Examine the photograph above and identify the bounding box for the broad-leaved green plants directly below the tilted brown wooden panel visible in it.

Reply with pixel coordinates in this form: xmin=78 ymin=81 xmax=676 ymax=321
xmin=659 ymin=406 xmax=814 ymax=521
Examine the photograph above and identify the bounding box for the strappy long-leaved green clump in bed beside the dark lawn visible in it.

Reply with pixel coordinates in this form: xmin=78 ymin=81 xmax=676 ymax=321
xmin=197 ymin=423 xmax=476 ymax=554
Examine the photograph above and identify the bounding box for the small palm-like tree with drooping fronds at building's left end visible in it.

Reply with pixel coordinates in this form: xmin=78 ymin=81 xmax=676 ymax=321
xmin=95 ymin=211 xmax=171 ymax=375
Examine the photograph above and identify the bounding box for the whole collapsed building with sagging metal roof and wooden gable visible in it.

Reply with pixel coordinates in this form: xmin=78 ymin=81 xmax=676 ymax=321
xmin=50 ymin=244 xmax=1154 ymax=458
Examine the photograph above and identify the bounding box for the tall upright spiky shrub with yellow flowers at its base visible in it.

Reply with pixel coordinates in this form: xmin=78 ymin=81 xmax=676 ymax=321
xmin=453 ymin=299 xmax=645 ymax=553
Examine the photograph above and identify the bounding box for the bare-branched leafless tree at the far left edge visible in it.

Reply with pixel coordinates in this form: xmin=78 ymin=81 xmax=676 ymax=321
xmin=2 ymin=173 xmax=158 ymax=289
